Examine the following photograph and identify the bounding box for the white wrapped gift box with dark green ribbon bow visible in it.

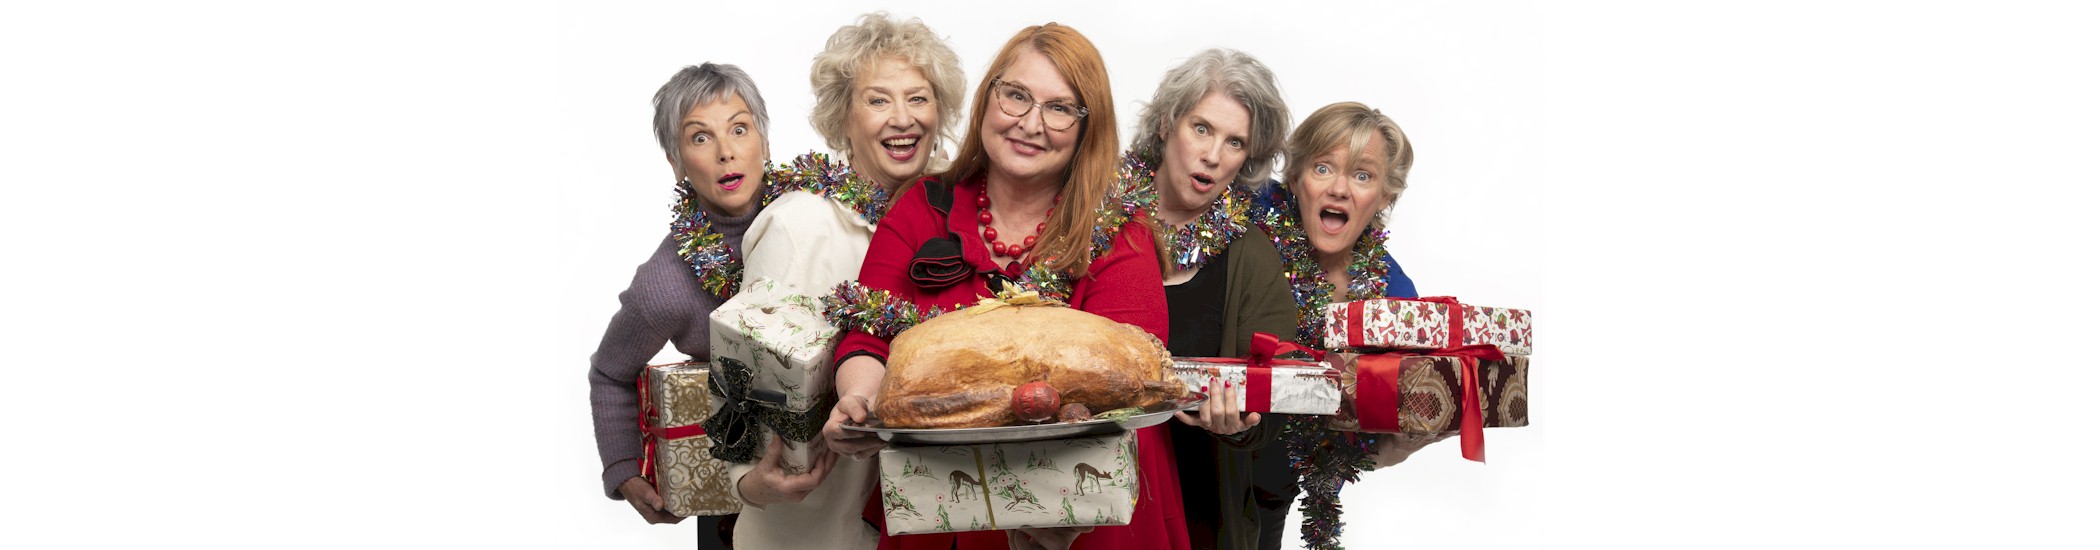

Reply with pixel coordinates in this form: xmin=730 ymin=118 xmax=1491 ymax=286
xmin=708 ymin=279 xmax=838 ymax=474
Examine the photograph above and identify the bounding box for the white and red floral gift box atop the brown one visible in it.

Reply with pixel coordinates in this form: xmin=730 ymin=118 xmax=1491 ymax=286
xmin=1323 ymin=298 xmax=1531 ymax=355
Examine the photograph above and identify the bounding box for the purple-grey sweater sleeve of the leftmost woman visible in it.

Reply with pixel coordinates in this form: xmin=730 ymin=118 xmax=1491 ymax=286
xmin=590 ymin=272 xmax=670 ymax=500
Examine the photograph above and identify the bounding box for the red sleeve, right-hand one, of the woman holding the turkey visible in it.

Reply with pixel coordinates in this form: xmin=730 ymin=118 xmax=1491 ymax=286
xmin=1073 ymin=220 xmax=1168 ymax=342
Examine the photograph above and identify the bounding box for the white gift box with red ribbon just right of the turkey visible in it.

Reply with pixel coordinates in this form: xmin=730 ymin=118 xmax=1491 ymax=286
xmin=1174 ymin=357 xmax=1342 ymax=414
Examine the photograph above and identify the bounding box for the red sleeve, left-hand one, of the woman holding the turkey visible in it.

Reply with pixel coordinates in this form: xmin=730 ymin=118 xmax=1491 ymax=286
xmin=832 ymin=185 xmax=943 ymax=363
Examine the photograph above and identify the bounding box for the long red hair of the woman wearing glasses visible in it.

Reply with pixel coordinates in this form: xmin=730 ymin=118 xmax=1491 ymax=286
xmin=941 ymin=23 xmax=1121 ymax=275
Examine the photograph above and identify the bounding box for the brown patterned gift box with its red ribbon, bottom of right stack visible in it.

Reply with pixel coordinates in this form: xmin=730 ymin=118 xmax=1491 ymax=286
xmin=1327 ymin=353 xmax=1531 ymax=460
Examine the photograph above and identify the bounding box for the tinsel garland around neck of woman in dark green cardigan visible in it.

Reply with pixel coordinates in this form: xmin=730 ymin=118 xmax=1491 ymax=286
xmin=1113 ymin=149 xmax=1254 ymax=271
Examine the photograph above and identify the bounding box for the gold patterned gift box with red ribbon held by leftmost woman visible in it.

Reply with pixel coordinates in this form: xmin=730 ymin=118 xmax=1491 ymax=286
xmin=641 ymin=363 xmax=743 ymax=516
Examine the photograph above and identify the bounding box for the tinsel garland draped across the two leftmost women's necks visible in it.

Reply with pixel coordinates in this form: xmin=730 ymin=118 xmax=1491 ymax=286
xmin=670 ymin=153 xmax=890 ymax=300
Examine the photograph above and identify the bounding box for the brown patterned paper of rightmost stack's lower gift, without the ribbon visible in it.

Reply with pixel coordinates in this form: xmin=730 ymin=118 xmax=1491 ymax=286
xmin=1327 ymin=353 xmax=1531 ymax=435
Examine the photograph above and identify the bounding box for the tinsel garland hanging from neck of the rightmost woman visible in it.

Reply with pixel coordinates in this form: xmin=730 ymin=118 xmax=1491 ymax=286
xmin=1256 ymin=185 xmax=1386 ymax=550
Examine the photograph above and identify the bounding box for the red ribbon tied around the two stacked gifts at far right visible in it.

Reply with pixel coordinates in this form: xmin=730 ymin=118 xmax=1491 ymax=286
xmin=1348 ymin=296 xmax=1508 ymax=462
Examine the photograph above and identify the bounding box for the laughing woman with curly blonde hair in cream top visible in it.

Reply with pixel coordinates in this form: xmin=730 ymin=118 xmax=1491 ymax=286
xmin=729 ymin=13 xmax=964 ymax=548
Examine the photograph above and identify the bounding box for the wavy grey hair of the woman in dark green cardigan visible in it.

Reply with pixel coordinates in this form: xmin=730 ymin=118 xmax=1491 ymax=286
xmin=1130 ymin=48 xmax=1292 ymax=189
